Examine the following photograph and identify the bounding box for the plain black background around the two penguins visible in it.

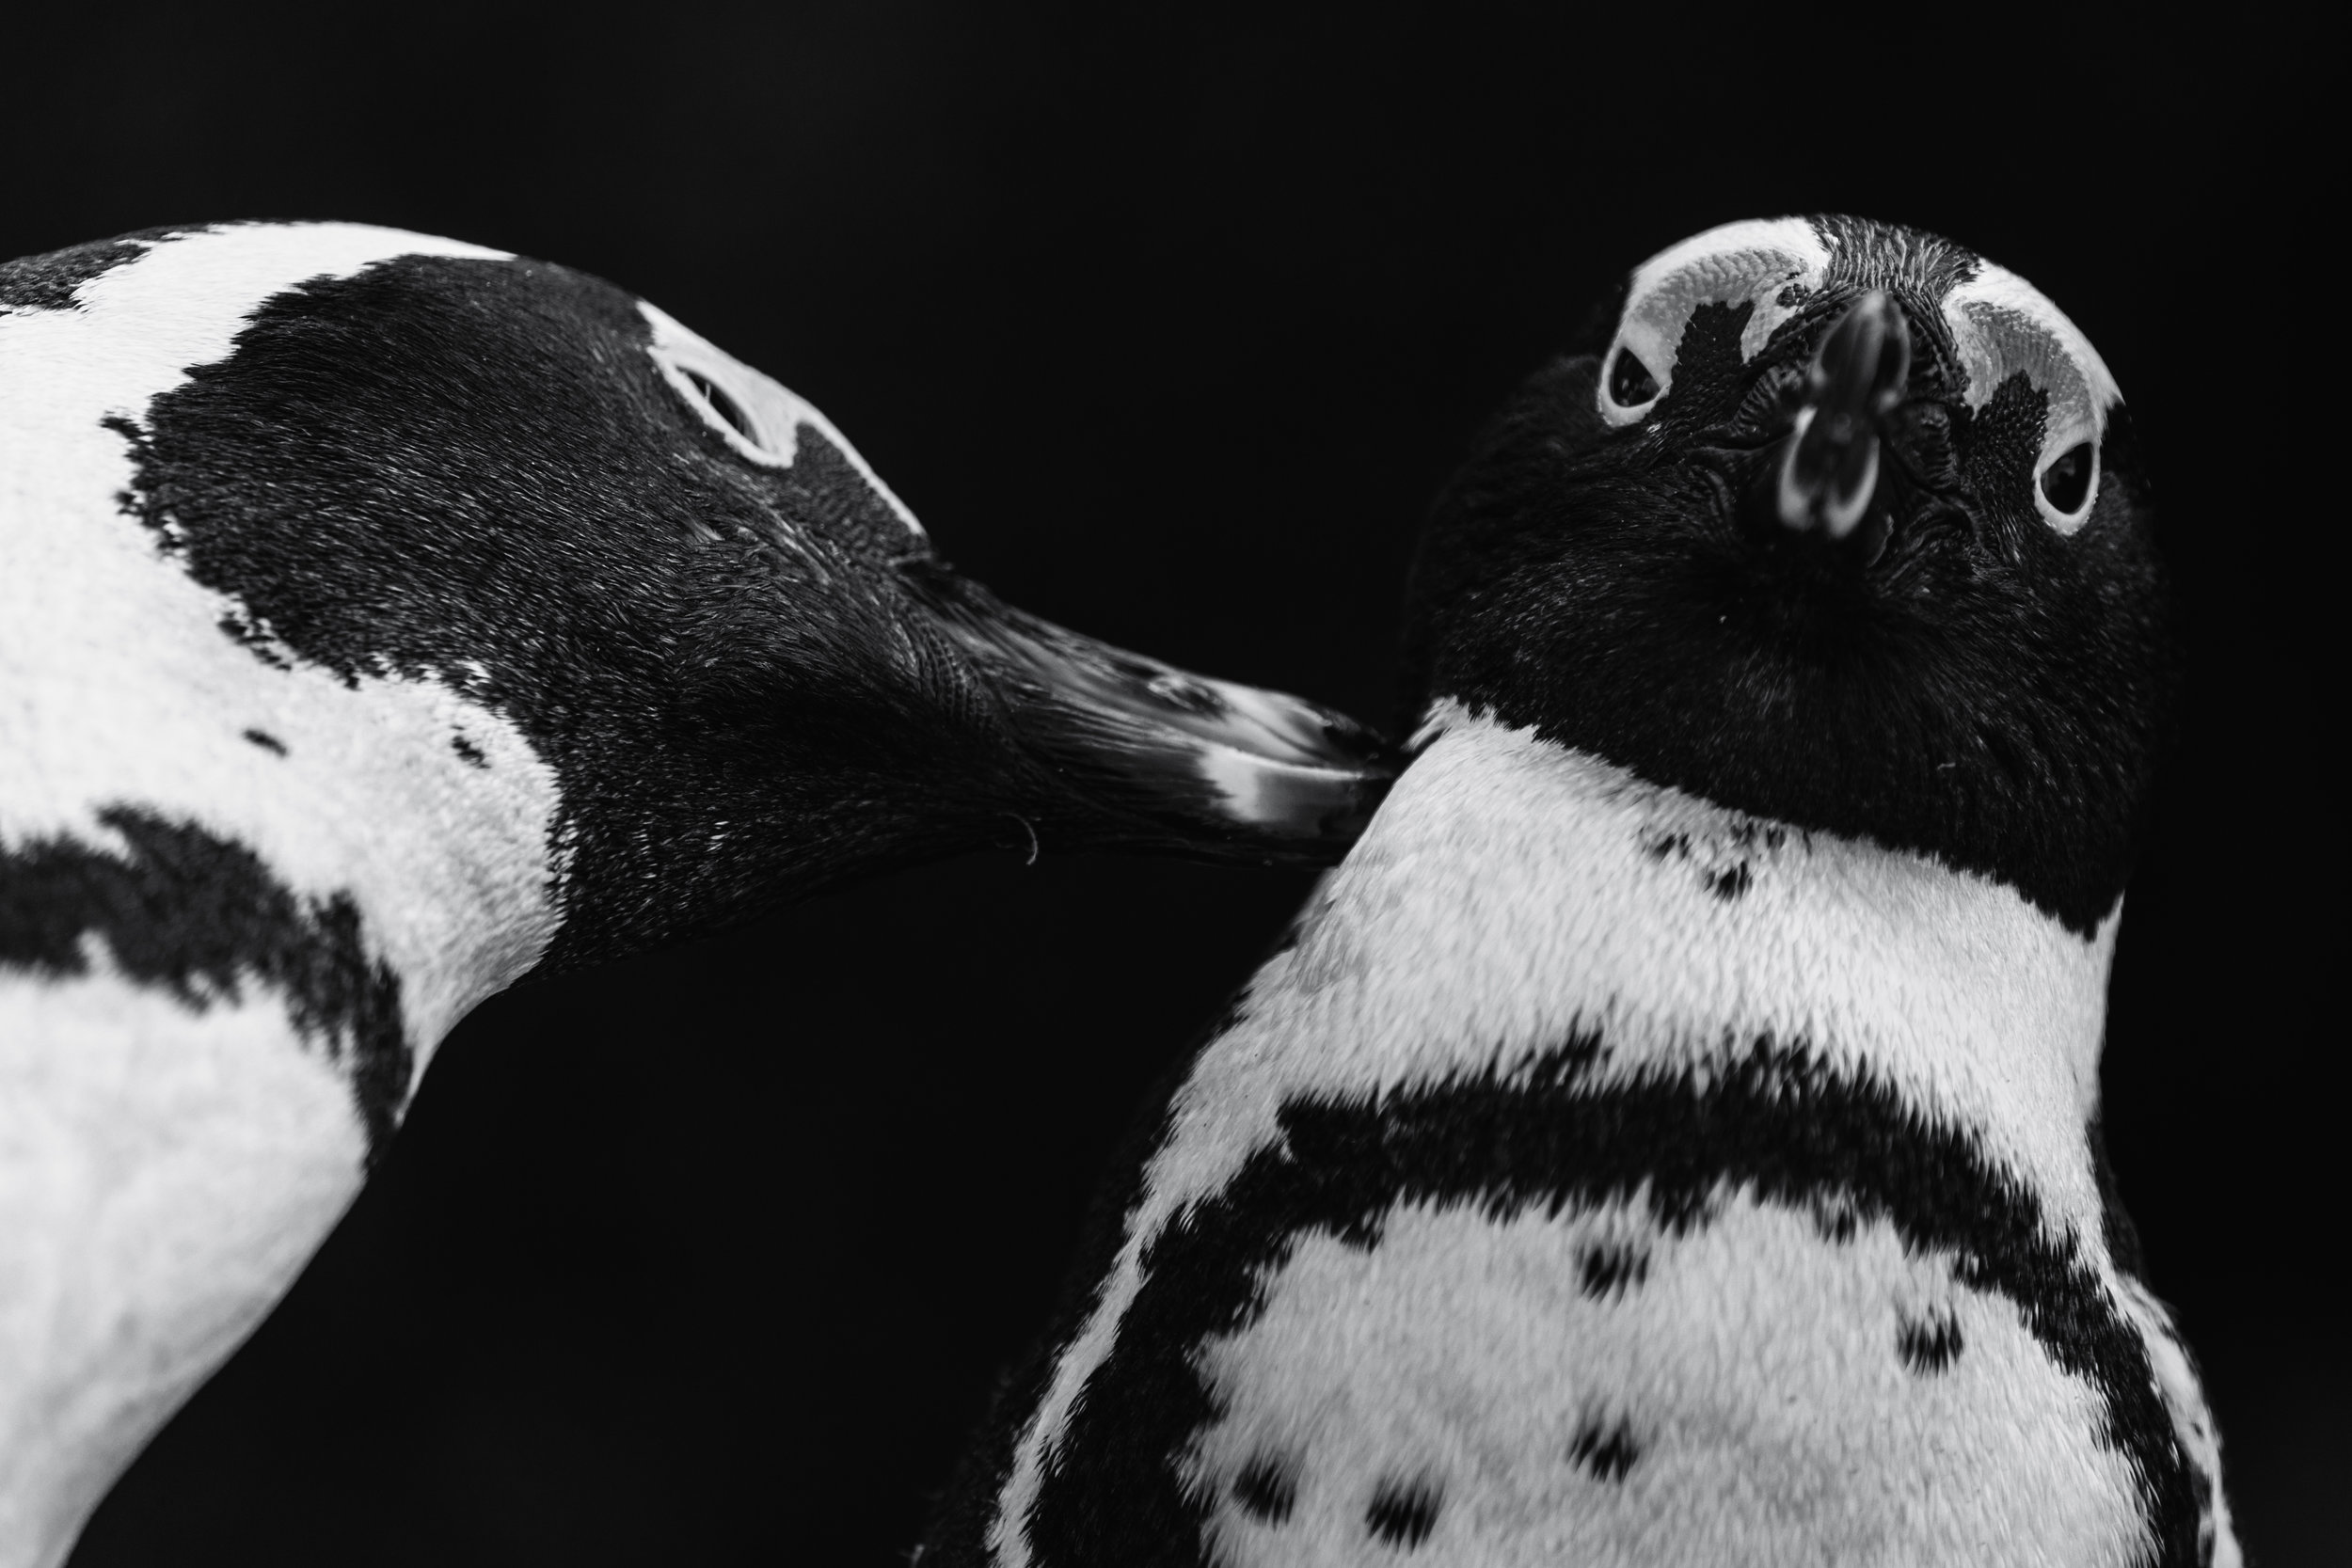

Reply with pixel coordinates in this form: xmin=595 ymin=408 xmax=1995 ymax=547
xmin=0 ymin=2 xmax=2352 ymax=1568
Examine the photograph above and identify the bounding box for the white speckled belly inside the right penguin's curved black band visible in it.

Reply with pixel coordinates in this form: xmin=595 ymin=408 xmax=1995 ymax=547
xmin=1185 ymin=1195 xmax=2143 ymax=1568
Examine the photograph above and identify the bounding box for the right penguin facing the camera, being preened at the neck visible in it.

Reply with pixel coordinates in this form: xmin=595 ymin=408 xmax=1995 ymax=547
xmin=922 ymin=218 xmax=2237 ymax=1568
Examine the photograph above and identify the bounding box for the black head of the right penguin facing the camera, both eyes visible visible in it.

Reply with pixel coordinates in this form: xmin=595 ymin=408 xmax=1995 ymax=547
xmin=1411 ymin=216 xmax=2173 ymax=933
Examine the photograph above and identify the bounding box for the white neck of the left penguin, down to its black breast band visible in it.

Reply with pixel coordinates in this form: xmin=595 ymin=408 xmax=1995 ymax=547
xmin=0 ymin=226 xmax=560 ymax=1085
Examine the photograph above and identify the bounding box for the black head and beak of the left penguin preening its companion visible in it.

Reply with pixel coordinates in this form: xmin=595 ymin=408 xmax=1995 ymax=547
xmin=17 ymin=226 xmax=1391 ymax=966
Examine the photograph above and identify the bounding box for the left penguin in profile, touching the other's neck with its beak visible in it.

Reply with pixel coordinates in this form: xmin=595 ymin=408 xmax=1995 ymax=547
xmin=0 ymin=226 xmax=1388 ymax=1568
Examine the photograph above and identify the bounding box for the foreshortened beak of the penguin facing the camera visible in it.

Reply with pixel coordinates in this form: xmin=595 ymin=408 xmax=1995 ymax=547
xmin=1776 ymin=289 xmax=1910 ymax=538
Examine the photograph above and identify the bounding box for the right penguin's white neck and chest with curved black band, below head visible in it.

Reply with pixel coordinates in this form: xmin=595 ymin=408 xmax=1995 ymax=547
xmin=991 ymin=712 xmax=2195 ymax=1563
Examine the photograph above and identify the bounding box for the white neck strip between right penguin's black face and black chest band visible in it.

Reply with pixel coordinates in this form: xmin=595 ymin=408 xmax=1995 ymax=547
xmin=1179 ymin=703 xmax=2117 ymax=1234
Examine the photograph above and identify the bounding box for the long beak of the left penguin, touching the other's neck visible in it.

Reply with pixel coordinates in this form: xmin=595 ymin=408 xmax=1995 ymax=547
xmin=920 ymin=571 xmax=1402 ymax=863
